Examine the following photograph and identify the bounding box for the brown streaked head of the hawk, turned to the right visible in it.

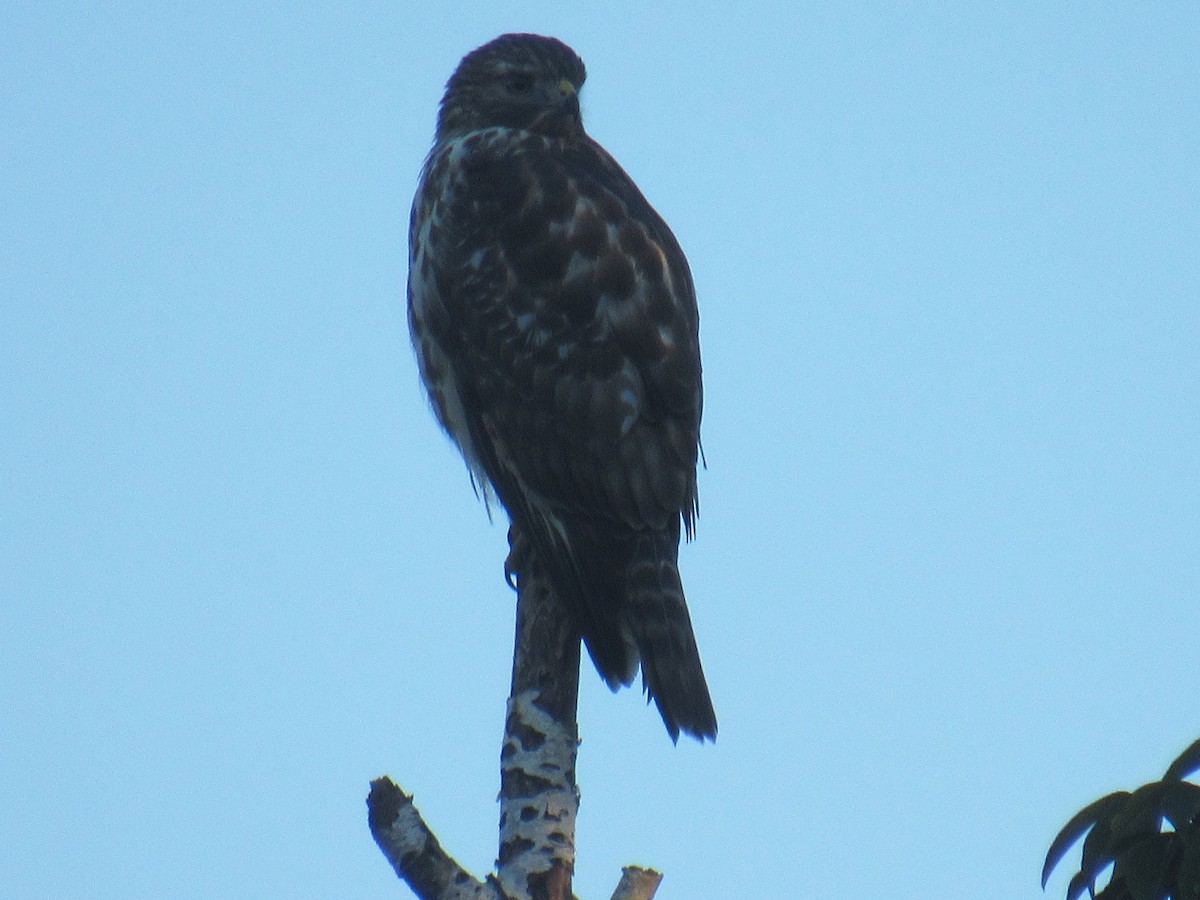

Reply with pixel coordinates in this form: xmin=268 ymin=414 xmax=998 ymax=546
xmin=437 ymin=35 xmax=587 ymax=140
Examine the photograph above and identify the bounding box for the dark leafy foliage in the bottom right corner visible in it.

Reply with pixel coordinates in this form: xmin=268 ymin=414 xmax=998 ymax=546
xmin=1042 ymin=740 xmax=1200 ymax=900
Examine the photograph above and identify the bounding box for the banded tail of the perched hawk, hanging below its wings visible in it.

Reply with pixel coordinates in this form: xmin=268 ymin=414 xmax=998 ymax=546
xmin=625 ymin=533 xmax=716 ymax=742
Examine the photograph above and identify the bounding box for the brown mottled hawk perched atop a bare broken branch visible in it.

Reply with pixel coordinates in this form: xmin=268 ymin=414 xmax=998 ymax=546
xmin=408 ymin=35 xmax=716 ymax=742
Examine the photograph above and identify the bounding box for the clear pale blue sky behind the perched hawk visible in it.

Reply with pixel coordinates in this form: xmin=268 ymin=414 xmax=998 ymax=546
xmin=0 ymin=0 xmax=1200 ymax=900
